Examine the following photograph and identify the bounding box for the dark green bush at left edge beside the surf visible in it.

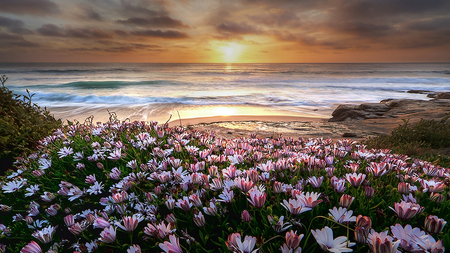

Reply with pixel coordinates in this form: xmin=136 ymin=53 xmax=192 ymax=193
xmin=0 ymin=76 xmax=62 ymax=171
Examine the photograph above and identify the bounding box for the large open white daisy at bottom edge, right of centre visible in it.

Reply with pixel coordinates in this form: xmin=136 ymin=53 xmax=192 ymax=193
xmin=311 ymin=227 xmax=356 ymax=253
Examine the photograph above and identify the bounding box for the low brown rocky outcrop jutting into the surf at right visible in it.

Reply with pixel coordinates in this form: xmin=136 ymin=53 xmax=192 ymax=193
xmin=328 ymin=98 xmax=450 ymax=122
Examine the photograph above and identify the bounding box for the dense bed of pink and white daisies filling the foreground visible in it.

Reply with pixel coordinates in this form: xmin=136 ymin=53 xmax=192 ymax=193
xmin=0 ymin=119 xmax=450 ymax=253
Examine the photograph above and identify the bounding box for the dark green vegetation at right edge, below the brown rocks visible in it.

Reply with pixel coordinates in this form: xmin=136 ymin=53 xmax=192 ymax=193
xmin=366 ymin=114 xmax=450 ymax=168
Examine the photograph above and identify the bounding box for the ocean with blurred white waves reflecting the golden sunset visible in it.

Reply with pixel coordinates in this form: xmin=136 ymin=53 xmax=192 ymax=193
xmin=0 ymin=63 xmax=450 ymax=123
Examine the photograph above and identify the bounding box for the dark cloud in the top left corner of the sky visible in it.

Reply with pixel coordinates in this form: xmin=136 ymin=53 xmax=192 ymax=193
xmin=0 ymin=0 xmax=60 ymax=16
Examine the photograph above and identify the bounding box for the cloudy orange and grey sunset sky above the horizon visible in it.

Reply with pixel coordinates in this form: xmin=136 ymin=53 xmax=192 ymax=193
xmin=0 ymin=0 xmax=450 ymax=63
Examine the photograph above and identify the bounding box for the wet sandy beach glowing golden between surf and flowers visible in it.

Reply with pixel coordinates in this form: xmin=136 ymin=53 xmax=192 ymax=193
xmin=169 ymin=99 xmax=450 ymax=141
